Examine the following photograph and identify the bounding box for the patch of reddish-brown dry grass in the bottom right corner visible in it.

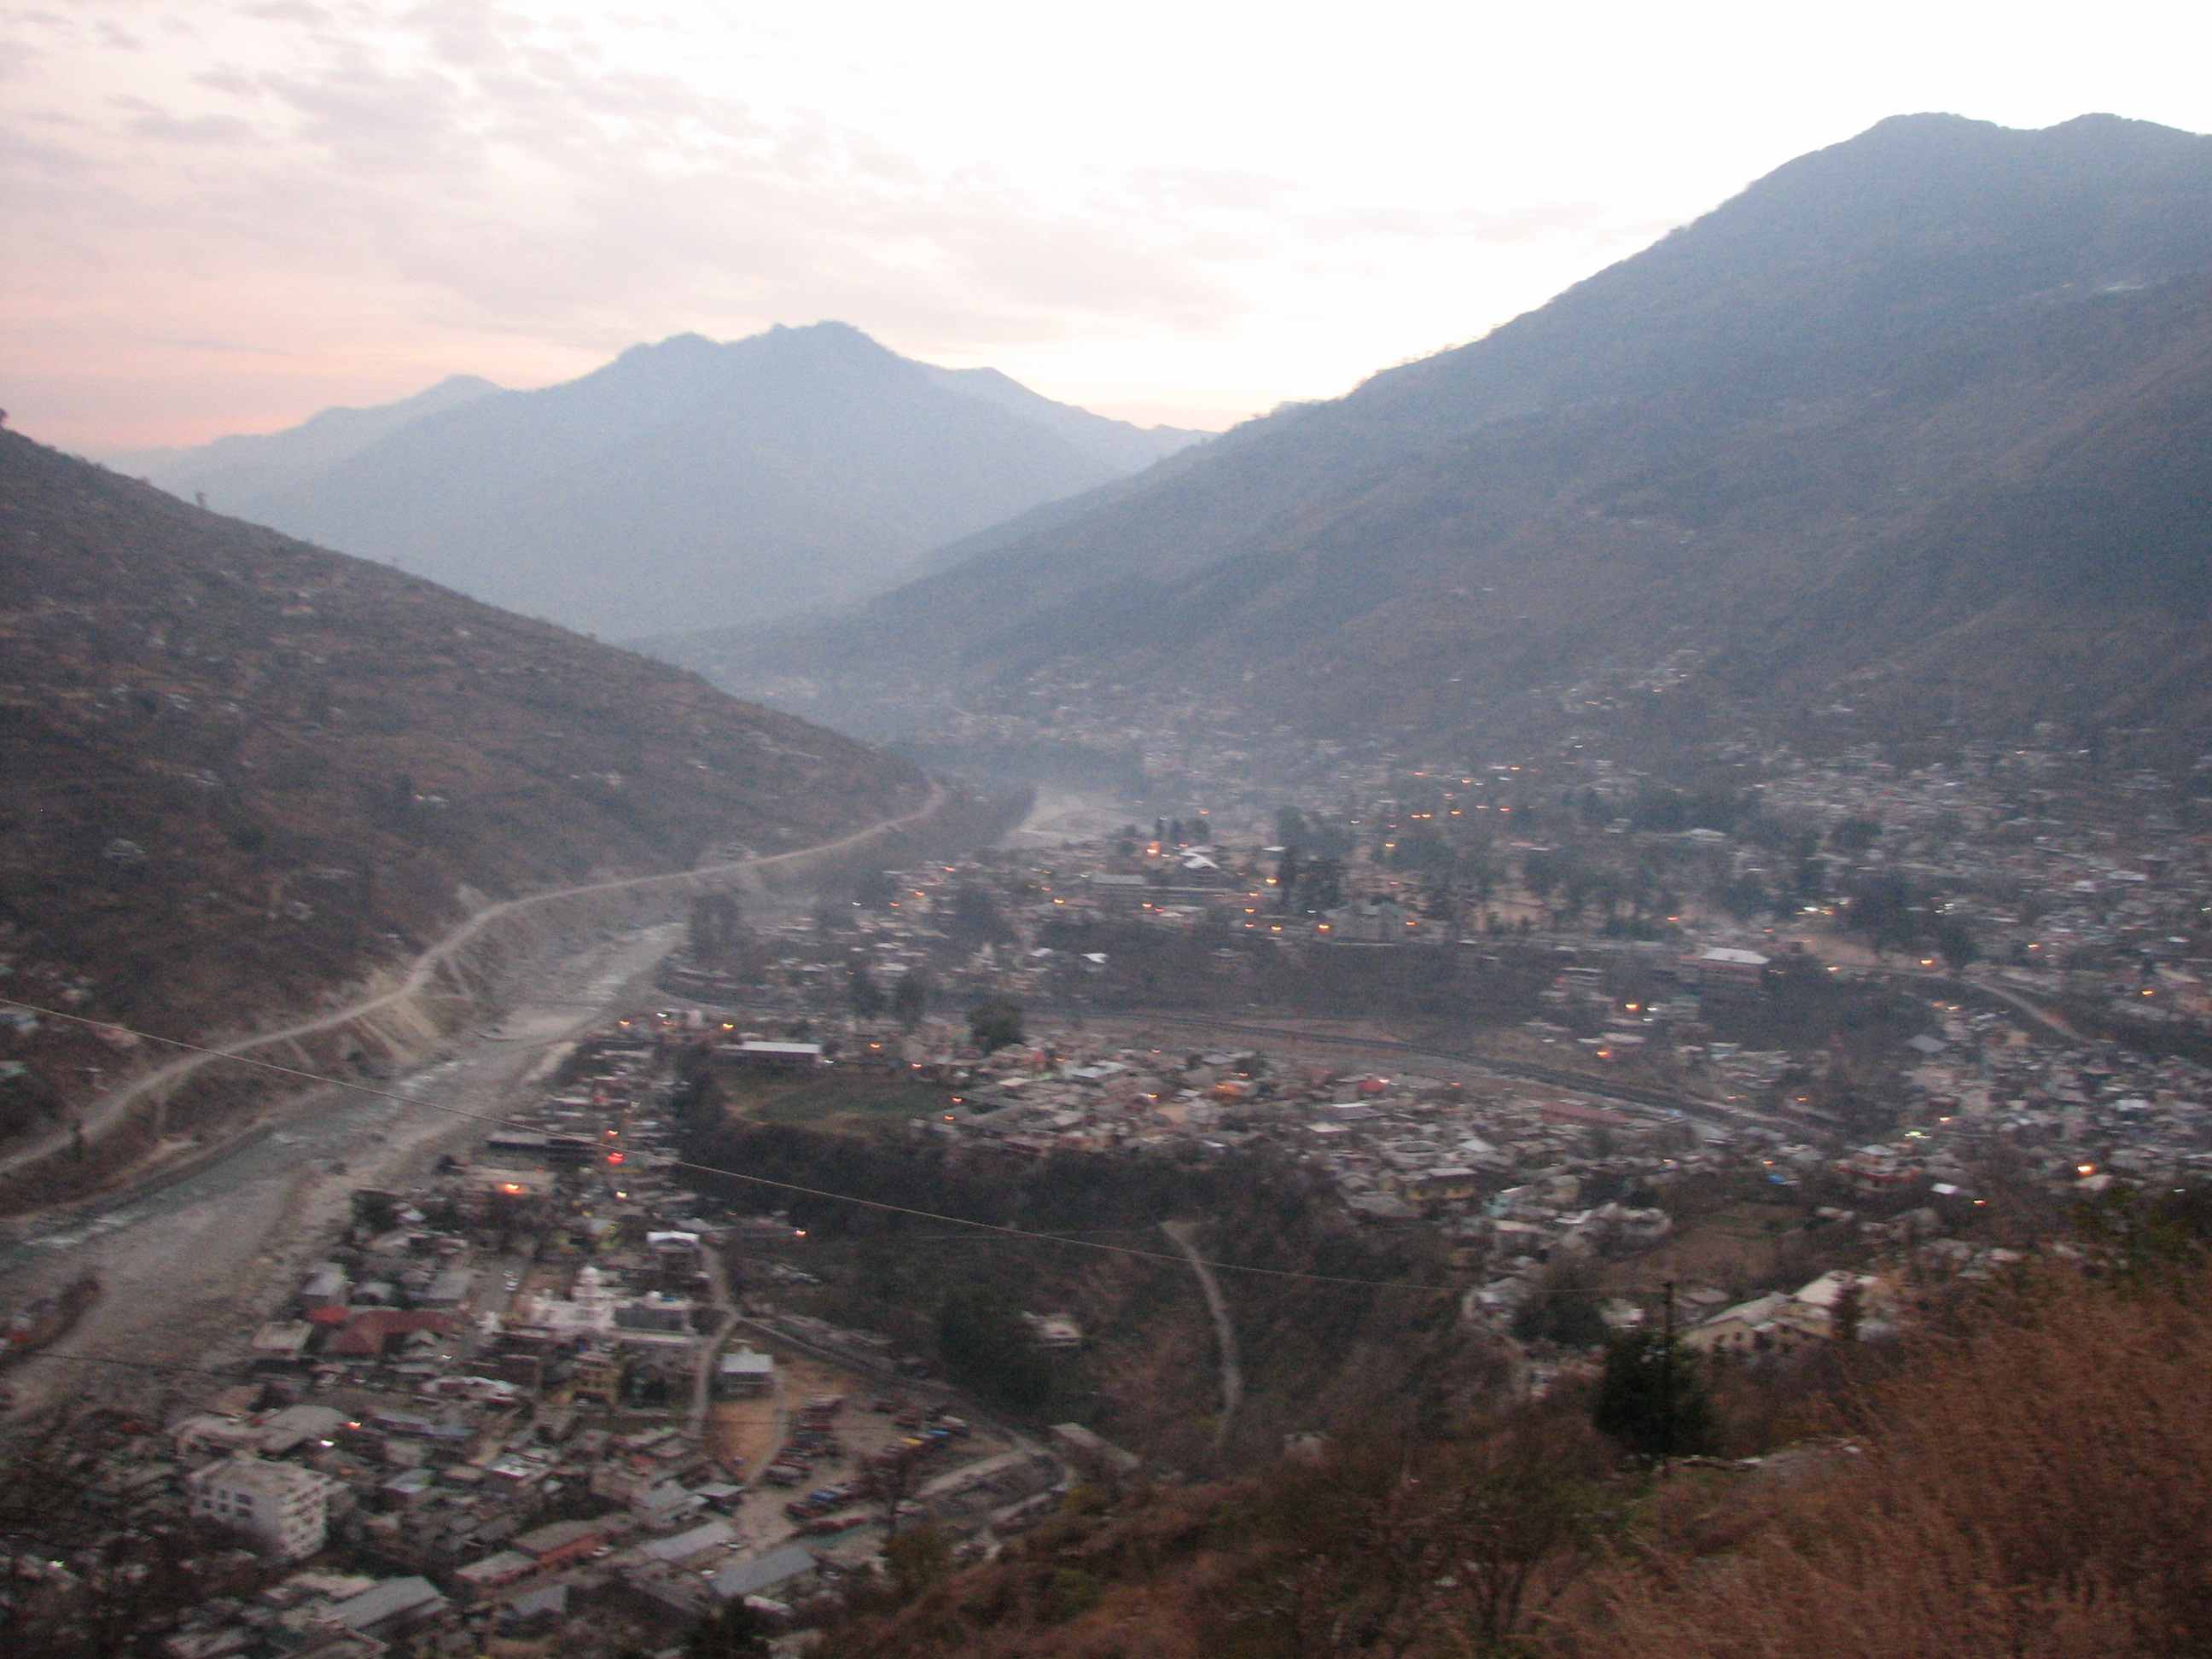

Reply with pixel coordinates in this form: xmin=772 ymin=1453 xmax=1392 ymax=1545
xmin=1557 ymin=1278 xmax=2212 ymax=1659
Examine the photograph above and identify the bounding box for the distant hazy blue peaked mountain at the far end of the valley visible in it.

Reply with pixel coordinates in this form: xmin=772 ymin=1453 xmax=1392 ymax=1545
xmin=120 ymin=323 xmax=1203 ymax=637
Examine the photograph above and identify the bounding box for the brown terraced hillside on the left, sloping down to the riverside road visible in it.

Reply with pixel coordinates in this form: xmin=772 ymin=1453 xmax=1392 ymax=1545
xmin=0 ymin=434 xmax=929 ymax=1132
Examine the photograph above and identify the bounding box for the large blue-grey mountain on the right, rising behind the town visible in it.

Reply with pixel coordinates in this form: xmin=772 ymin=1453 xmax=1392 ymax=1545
xmin=657 ymin=115 xmax=2212 ymax=752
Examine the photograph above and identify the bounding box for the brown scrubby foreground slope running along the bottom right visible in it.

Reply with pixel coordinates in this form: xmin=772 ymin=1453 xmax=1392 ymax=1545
xmin=832 ymin=1274 xmax=2212 ymax=1659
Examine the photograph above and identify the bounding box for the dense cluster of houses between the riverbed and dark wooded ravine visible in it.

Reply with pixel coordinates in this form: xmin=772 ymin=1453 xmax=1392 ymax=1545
xmin=33 ymin=1017 xmax=1080 ymax=1659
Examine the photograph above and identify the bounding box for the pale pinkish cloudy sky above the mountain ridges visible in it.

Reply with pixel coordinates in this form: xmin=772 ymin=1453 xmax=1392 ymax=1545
xmin=0 ymin=0 xmax=2212 ymax=453
